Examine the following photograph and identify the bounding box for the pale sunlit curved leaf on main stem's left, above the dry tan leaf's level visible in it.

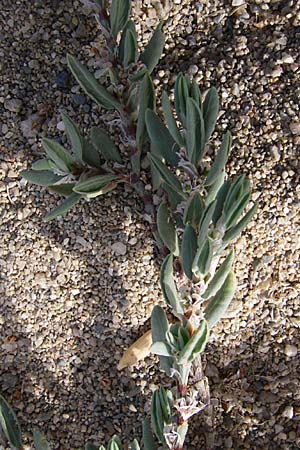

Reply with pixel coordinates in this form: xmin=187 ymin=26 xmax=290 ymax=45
xmin=160 ymin=254 xmax=184 ymax=314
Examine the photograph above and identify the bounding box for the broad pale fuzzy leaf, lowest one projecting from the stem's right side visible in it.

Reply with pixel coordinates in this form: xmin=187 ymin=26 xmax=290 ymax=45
xmin=204 ymin=272 xmax=236 ymax=328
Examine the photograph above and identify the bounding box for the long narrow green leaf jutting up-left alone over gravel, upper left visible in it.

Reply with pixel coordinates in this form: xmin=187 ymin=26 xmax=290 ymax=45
xmin=67 ymin=54 xmax=120 ymax=109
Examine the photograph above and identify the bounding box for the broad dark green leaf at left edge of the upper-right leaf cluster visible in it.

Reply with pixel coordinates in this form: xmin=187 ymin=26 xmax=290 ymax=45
xmin=145 ymin=109 xmax=179 ymax=167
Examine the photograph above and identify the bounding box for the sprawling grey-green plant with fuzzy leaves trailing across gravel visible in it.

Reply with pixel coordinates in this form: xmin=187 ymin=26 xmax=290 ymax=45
xmin=0 ymin=0 xmax=256 ymax=450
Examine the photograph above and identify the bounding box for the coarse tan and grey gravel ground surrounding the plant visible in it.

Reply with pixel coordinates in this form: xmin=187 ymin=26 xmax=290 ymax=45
xmin=0 ymin=0 xmax=300 ymax=450
